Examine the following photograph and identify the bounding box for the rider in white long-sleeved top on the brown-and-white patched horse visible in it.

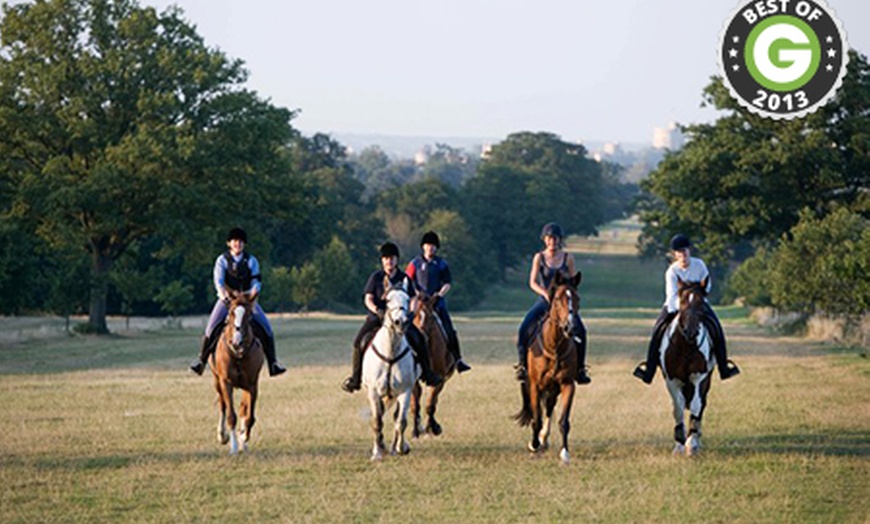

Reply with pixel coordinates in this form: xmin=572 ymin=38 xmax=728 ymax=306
xmin=634 ymin=234 xmax=740 ymax=384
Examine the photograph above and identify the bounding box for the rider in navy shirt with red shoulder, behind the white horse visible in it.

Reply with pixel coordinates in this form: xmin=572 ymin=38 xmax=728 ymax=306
xmin=405 ymin=231 xmax=471 ymax=373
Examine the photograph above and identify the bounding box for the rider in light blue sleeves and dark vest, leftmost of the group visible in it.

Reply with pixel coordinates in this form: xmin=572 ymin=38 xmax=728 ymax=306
xmin=190 ymin=227 xmax=287 ymax=377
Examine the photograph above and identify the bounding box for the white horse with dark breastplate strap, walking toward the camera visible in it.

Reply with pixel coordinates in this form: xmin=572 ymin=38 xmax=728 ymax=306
xmin=362 ymin=279 xmax=419 ymax=461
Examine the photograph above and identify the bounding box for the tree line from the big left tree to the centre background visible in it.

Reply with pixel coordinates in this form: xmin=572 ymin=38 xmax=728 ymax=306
xmin=0 ymin=0 xmax=632 ymax=333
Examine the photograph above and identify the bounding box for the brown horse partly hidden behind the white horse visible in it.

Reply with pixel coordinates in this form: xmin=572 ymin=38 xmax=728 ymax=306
xmin=411 ymin=295 xmax=456 ymax=438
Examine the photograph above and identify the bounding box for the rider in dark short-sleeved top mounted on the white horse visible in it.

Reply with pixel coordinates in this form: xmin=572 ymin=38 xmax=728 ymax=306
xmin=341 ymin=242 xmax=443 ymax=393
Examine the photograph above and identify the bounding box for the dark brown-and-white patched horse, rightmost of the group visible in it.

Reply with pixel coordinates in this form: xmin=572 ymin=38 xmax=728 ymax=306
xmin=659 ymin=279 xmax=716 ymax=456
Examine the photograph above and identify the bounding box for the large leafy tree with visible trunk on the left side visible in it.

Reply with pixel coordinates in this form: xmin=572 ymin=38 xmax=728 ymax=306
xmin=0 ymin=0 xmax=294 ymax=332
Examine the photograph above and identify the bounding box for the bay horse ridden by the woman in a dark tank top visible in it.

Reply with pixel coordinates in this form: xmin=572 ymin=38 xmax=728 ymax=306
xmin=514 ymin=271 xmax=583 ymax=464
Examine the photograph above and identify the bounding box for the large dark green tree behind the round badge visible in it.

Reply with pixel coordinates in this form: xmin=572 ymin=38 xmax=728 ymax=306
xmin=639 ymin=52 xmax=870 ymax=262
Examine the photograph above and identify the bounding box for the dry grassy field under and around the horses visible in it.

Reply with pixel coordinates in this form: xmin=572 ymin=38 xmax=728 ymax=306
xmin=0 ymin=234 xmax=870 ymax=523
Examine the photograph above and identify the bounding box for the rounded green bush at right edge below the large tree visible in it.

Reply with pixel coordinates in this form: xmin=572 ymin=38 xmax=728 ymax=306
xmin=770 ymin=209 xmax=870 ymax=320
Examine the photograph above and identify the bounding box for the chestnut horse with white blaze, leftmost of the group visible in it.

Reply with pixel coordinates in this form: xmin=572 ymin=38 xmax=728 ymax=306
xmin=209 ymin=291 xmax=265 ymax=455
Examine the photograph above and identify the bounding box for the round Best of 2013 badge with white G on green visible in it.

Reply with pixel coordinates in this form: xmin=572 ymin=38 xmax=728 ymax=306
xmin=719 ymin=0 xmax=849 ymax=120
